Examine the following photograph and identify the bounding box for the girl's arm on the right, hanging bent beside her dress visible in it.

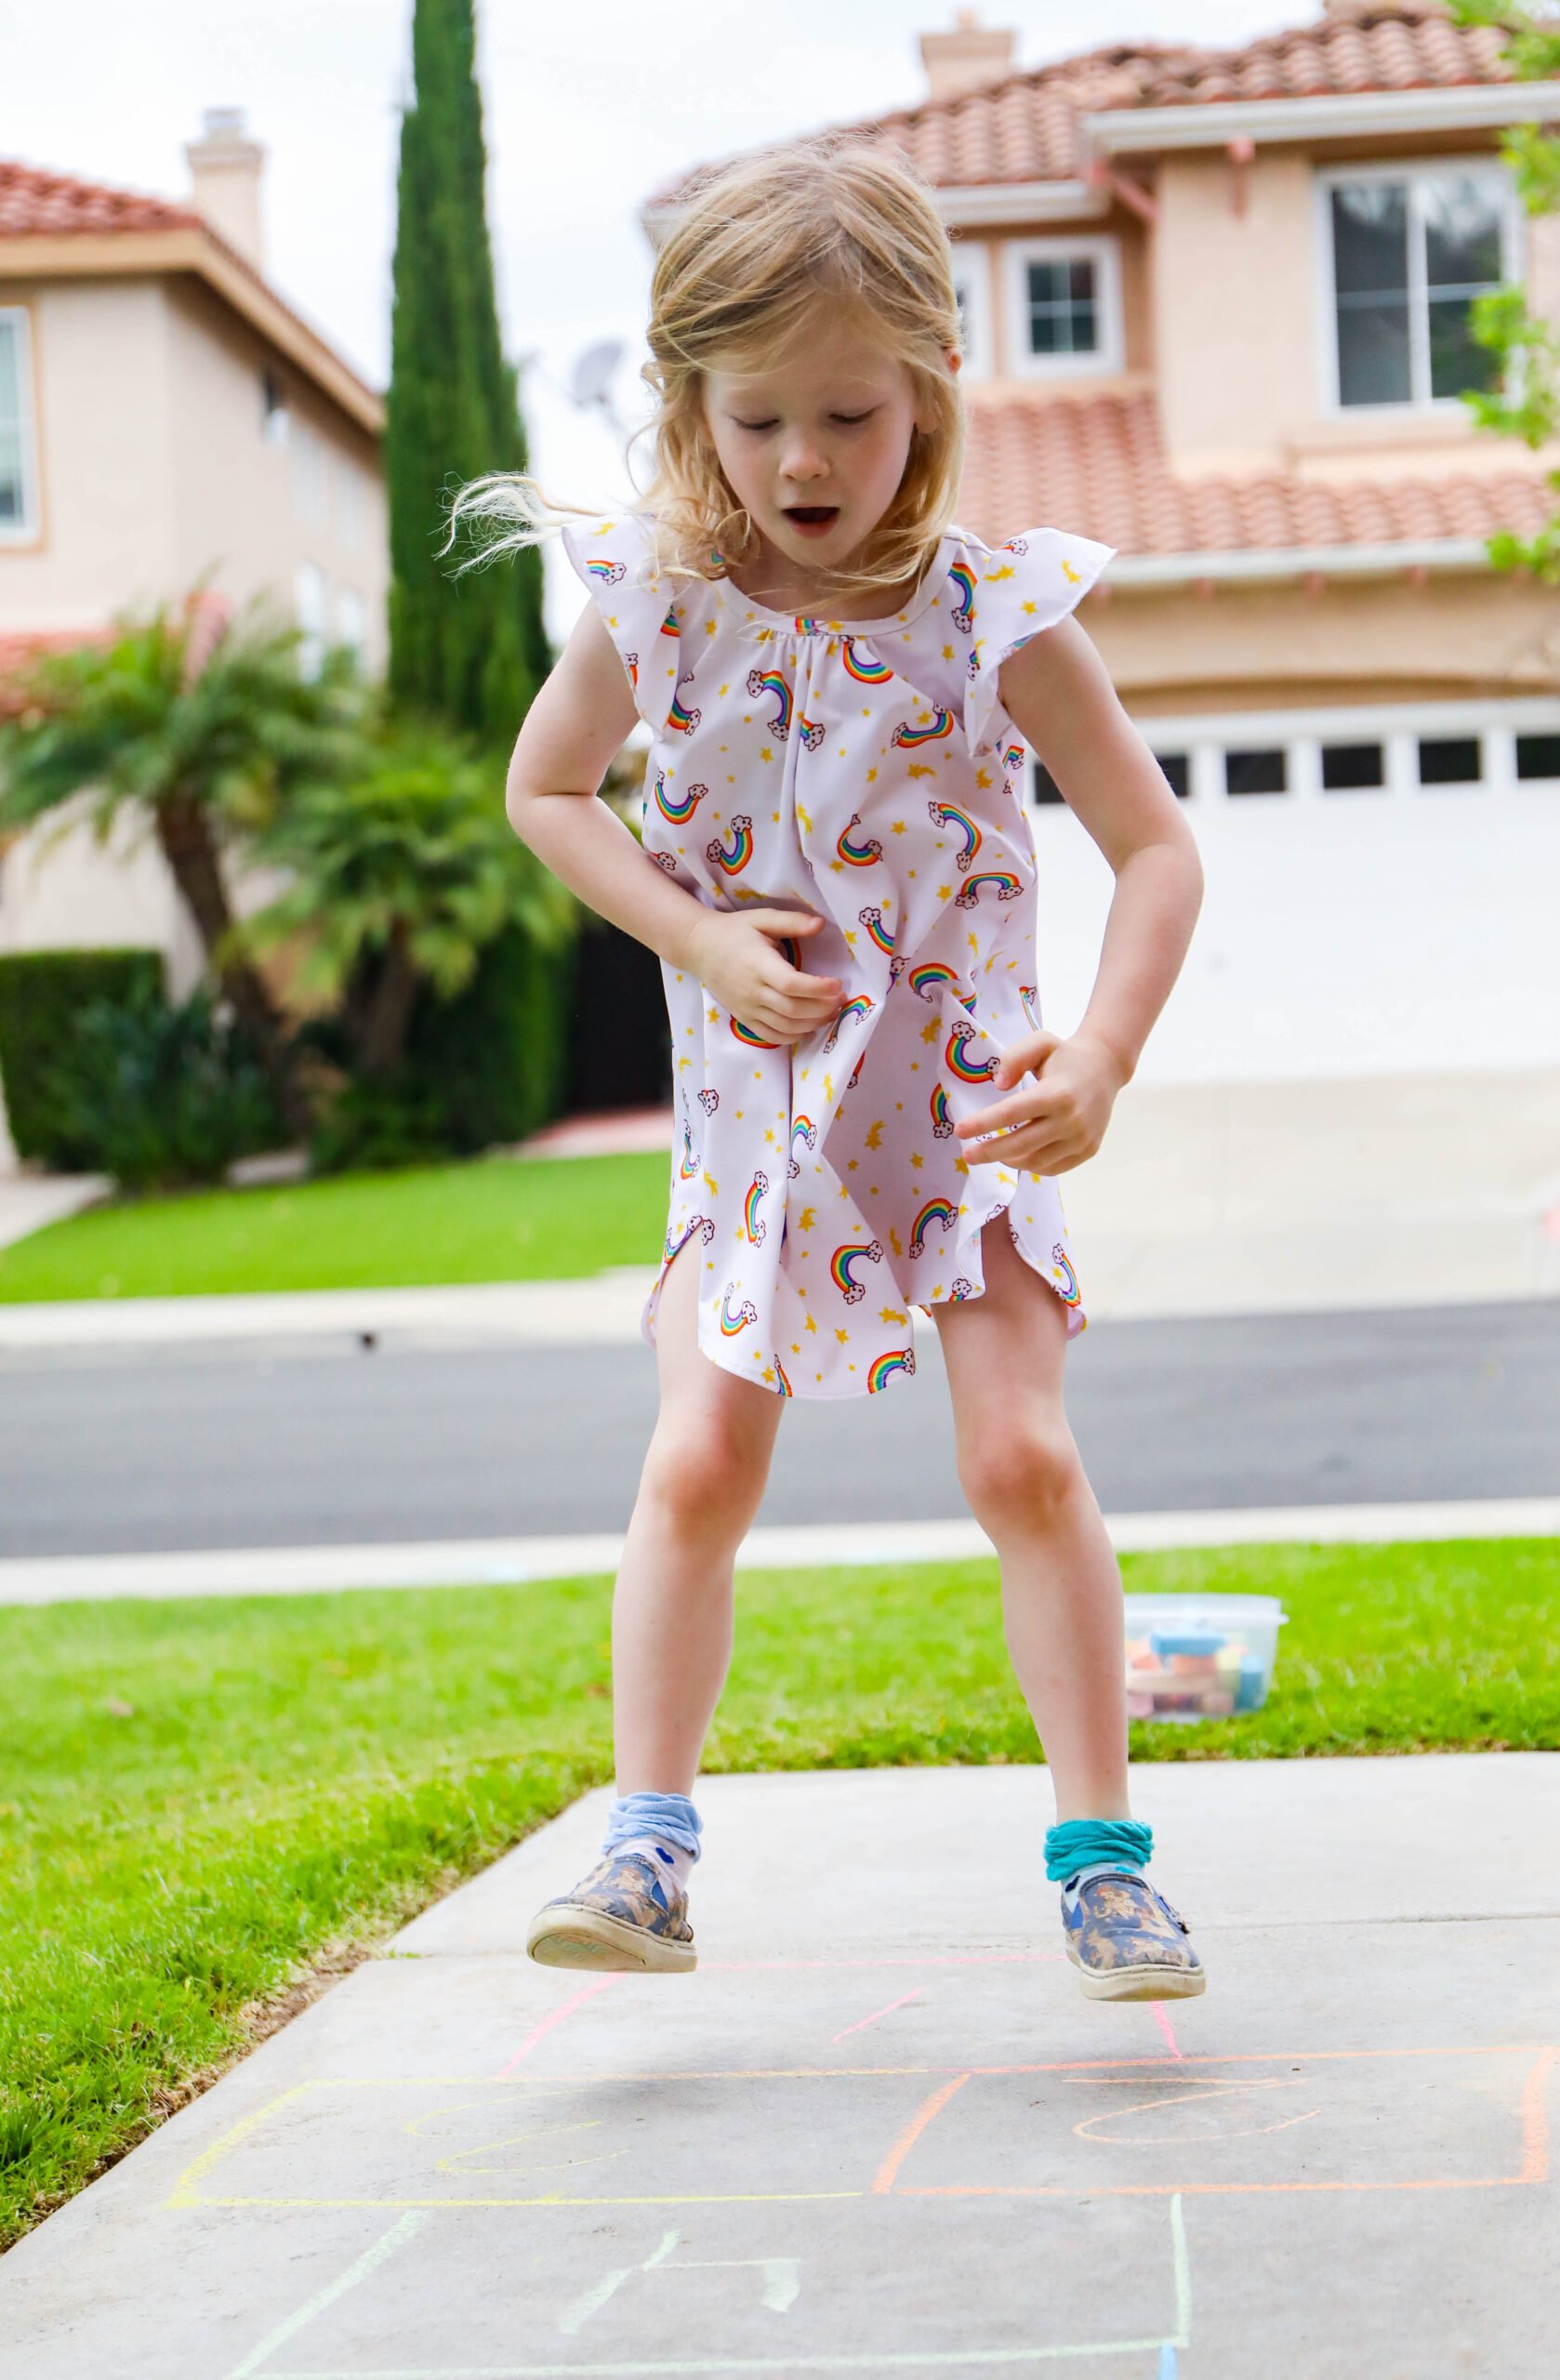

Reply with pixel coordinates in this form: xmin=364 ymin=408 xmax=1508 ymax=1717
xmin=955 ymin=619 xmax=1203 ymax=1173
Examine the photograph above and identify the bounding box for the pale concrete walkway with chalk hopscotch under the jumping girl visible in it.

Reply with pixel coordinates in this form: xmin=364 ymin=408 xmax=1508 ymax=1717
xmin=0 ymin=1754 xmax=1560 ymax=2380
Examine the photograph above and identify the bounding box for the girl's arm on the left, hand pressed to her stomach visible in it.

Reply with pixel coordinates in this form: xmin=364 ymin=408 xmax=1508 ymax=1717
xmin=505 ymin=604 xmax=843 ymax=1040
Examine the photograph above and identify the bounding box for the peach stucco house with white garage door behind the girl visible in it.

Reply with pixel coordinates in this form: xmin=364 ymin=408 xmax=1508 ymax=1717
xmin=645 ymin=0 xmax=1560 ymax=1080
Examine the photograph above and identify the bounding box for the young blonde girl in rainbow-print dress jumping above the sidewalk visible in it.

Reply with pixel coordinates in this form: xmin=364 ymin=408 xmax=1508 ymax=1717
xmin=457 ymin=140 xmax=1205 ymax=1999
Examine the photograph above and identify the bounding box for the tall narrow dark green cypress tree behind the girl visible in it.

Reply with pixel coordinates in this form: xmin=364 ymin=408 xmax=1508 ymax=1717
xmin=386 ymin=0 xmax=550 ymax=745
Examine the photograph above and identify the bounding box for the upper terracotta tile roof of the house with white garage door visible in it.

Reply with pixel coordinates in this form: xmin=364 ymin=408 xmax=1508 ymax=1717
xmin=650 ymin=0 xmax=1513 ymax=207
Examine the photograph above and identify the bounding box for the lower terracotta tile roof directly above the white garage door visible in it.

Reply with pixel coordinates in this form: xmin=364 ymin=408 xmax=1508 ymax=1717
xmin=959 ymin=390 xmax=1553 ymax=576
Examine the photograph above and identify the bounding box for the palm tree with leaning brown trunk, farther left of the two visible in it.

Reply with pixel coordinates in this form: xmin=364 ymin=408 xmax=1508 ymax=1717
xmin=0 ymin=588 xmax=364 ymax=1130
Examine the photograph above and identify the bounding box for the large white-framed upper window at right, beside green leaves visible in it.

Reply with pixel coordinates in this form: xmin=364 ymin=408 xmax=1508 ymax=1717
xmin=1324 ymin=165 xmax=1517 ymax=407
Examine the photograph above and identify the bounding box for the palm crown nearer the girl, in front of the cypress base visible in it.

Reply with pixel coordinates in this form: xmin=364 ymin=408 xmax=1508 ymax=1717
xmin=236 ymin=721 xmax=576 ymax=1083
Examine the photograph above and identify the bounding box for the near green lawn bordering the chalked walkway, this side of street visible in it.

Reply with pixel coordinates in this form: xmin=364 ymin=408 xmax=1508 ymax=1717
xmin=0 ymin=1523 xmax=1560 ymax=2242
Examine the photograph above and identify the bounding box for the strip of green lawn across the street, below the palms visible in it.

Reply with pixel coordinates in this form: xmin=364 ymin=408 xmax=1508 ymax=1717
xmin=0 ymin=1149 xmax=667 ymax=1304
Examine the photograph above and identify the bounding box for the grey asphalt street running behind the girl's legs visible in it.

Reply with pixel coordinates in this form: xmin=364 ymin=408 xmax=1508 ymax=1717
xmin=0 ymin=1300 xmax=1560 ymax=1556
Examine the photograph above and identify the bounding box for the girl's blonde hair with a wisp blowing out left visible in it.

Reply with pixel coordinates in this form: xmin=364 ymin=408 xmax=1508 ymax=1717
xmin=445 ymin=133 xmax=965 ymax=609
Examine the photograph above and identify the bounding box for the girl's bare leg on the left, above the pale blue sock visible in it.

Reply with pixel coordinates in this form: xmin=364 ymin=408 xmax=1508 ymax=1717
xmin=612 ymin=1236 xmax=784 ymax=1794
